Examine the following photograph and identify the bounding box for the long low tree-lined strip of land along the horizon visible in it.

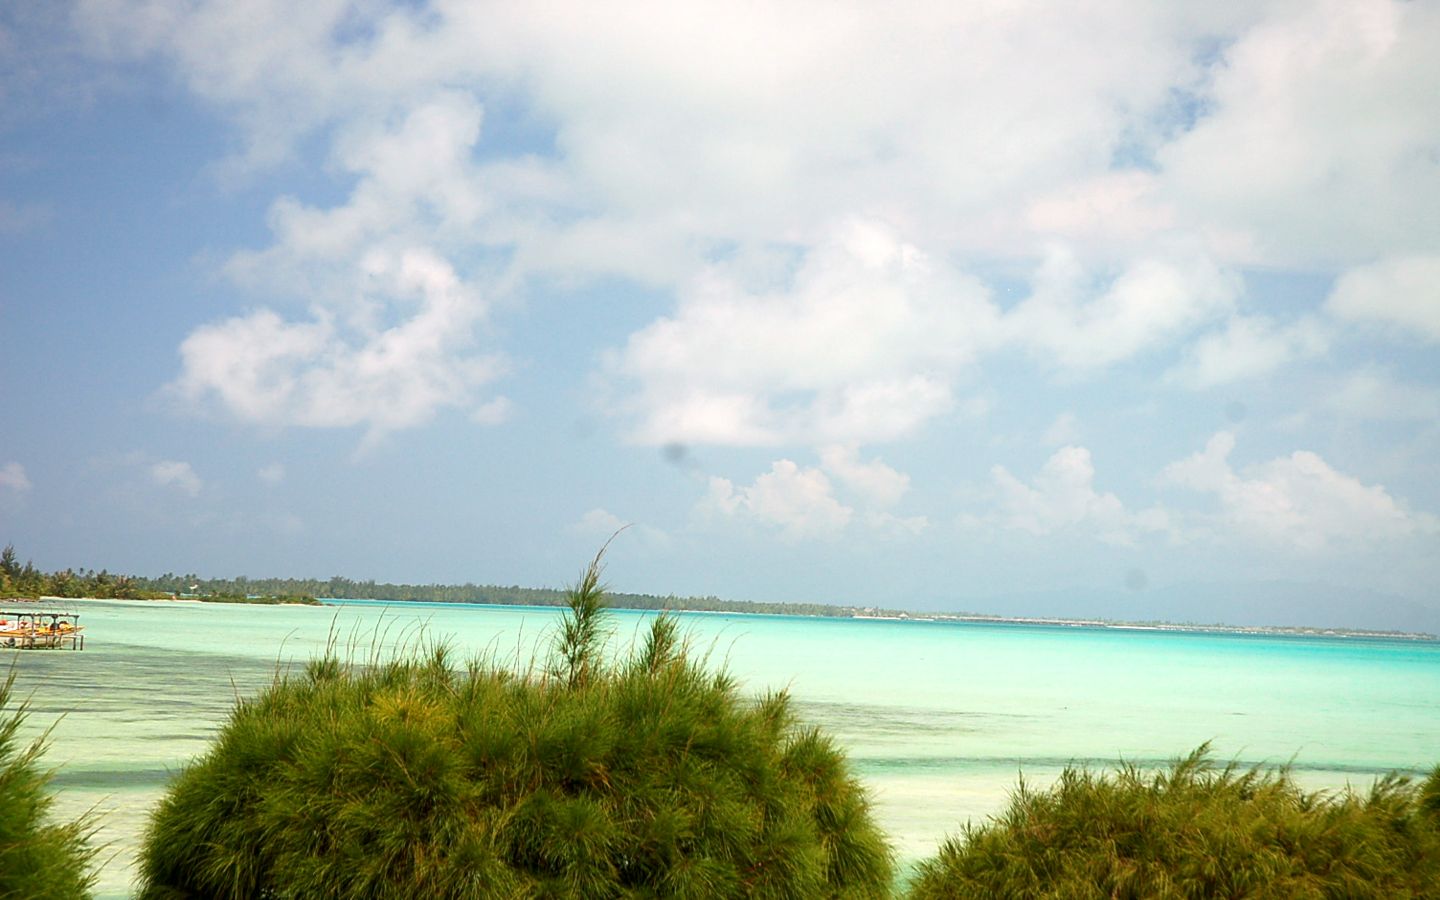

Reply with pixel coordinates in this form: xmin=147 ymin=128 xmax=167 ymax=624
xmin=0 ymin=546 xmax=1440 ymax=641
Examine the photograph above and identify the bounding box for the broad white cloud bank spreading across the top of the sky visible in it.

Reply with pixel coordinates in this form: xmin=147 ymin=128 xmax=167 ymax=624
xmin=75 ymin=0 xmax=1440 ymax=278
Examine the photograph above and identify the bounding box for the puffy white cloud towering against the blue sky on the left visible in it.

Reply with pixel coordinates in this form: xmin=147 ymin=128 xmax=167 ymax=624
xmin=153 ymin=91 xmax=508 ymax=436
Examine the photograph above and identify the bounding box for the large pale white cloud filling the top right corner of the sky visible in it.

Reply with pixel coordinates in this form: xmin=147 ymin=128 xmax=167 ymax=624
xmin=1158 ymin=0 xmax=1440 ymax=266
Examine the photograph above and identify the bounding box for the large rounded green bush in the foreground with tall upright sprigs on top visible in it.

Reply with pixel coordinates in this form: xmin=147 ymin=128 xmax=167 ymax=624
xmin=140 ymin=557 xmax=893 ymax=900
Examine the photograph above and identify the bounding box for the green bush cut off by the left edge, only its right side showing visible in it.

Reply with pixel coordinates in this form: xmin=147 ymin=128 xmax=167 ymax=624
xmin=0 ymin=668 xmax=95 ymax=900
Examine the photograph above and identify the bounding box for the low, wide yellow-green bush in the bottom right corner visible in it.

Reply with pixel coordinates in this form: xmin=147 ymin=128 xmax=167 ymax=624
xmin=910 ymin=746 xmax=1440 ymax=900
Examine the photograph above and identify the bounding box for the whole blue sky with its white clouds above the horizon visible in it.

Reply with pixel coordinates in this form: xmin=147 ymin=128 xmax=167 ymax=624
xmin=0 ymin=0 xmax=1440 ymax=631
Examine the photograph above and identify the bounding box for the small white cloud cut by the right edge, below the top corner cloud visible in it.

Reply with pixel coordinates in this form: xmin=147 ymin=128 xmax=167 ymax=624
xmin=1325 ymin=254 xmax=1440 ymax=341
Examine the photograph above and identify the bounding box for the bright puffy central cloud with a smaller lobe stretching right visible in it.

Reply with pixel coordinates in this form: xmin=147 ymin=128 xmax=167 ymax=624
xmin=608 ymin=219 xmax=1236 ymax=446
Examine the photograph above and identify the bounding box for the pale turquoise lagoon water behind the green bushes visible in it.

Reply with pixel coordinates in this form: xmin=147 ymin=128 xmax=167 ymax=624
xmin=17 ymin=600 xmax=1440 ymax=897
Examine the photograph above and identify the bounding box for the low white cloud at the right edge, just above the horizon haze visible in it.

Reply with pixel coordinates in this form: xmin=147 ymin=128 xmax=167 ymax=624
xmin=1161 ymin=432 xmax=1440 ymax=552
